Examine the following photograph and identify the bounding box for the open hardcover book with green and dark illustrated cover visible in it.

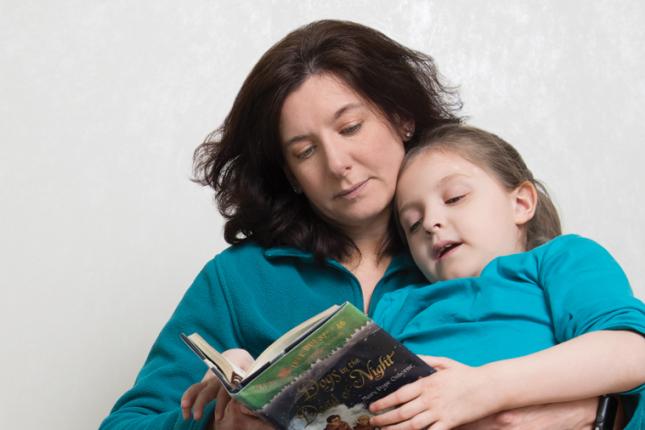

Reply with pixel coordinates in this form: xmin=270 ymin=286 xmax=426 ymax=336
xmin=181 ymin=302 xmax=435 ymax=430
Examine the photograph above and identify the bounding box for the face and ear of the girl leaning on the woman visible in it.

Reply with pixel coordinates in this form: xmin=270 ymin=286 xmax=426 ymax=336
xmin=396 ymin=149 xmax=532 ymax=281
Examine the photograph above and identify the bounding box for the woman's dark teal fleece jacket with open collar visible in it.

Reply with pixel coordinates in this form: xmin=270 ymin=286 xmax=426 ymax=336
xmin=100 ymin=243 xmax=425 ymax=430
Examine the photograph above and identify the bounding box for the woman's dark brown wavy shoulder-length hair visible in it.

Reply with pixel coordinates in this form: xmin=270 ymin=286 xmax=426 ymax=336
xmin=193 ymin=20 xmax=461 ymax=260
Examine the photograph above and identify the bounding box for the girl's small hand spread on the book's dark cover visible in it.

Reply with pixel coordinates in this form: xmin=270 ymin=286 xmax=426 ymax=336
xmin=370 ymin=356 xmax=501 ymax=430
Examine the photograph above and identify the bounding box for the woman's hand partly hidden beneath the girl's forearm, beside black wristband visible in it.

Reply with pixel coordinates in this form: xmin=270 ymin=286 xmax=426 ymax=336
xmin=456 ymin=397 xmax=600 ymax=430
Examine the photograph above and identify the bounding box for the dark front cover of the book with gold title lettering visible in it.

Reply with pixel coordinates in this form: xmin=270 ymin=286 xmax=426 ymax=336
xmin=262 ymin=321 xmax=433 ymax=430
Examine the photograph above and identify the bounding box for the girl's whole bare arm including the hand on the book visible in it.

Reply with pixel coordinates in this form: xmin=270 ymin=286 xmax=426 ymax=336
xmin=370 ymin=331 xmax=645 ymax=430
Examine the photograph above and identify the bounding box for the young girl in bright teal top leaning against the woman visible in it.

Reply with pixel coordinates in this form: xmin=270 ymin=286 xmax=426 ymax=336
xmin=371 ymin=125 xmax=645 ymax=430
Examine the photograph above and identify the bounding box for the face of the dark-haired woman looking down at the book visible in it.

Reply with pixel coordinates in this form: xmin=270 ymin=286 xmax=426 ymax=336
xmin=280 ymin=74 xmax=404 ymax=235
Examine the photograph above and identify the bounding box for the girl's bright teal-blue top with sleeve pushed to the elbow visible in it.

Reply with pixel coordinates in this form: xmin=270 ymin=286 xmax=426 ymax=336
xmin=373 ymin=235 xmax=645 ymax=410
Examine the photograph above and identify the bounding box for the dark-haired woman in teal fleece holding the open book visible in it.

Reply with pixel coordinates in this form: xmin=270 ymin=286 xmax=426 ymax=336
xmin=101 ymin=21 xmax=624 ymax=430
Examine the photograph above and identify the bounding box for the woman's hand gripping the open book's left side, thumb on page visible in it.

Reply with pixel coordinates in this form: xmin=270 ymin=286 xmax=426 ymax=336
xmin=181 ymin=349 xmax=273 ymax=430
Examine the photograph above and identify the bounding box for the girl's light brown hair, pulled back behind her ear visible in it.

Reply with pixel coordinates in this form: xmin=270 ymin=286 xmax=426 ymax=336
xmin=399 ymin=124 xmax=562 ymax=249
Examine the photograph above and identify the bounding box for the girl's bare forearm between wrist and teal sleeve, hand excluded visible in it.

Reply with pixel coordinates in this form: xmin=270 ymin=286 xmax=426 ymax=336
xmin=482 ymin=330 xmax=645 ymax=410
